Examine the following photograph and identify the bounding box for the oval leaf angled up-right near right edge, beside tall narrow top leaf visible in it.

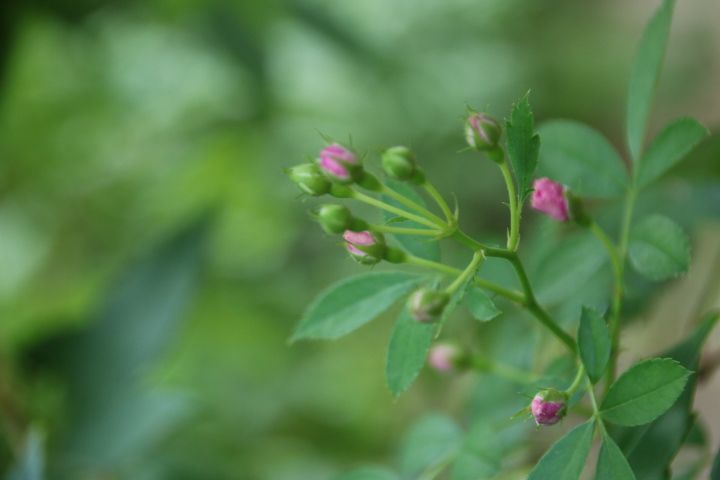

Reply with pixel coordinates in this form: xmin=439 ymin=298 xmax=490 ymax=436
xmin=637 ymin=118 xmax=709 ymax=188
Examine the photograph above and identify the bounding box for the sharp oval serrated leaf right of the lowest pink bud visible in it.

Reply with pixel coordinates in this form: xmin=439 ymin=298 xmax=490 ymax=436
xmin=600 ymin=358 xmax=690 ymax=426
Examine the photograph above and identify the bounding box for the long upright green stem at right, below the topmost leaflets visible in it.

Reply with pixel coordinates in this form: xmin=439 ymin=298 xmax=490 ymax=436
xmin=605 ymin=186 xmax=637 ymax=389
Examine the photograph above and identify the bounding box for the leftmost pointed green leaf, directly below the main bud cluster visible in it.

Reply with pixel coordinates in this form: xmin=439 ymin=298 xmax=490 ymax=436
xmin=292 ymin=272 xmax=422 ymax=341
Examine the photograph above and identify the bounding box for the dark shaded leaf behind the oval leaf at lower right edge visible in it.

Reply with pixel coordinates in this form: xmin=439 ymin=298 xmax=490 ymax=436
xmin=613 ymin=313 xmax=720 ymax=480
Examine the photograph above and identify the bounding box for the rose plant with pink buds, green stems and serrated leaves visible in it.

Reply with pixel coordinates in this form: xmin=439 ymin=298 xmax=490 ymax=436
xmin=288 ymin=0 xmax=718 ymax=480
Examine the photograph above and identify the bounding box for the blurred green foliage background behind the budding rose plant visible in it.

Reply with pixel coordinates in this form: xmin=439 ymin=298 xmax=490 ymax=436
xmin=0 ymin=0 xmax=720 ymax=480
